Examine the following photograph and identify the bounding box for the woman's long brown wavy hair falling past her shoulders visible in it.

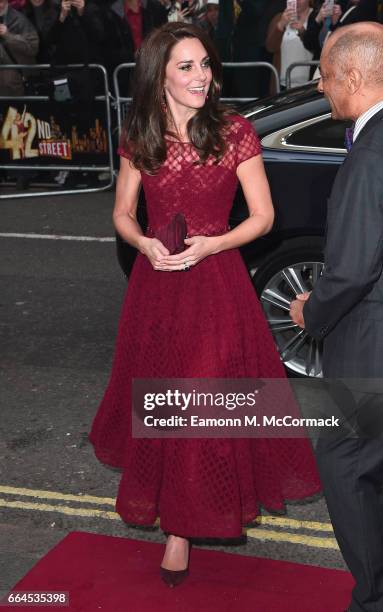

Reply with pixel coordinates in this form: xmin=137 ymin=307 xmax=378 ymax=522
xmin=121 ymin=22 xmax=233 ymax=174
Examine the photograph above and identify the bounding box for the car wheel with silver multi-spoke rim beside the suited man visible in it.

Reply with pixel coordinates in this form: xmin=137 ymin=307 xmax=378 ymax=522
xmin=253 ymin=246 xmax=323 ymax=378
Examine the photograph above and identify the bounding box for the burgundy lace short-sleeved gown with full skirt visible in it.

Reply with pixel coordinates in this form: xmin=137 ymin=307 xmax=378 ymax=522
xmin=89 ymin=115 xmax=321 ymax=537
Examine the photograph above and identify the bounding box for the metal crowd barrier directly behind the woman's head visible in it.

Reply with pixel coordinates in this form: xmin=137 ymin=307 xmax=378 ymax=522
xmin=113 ymin=62 xmax=281 ymax=136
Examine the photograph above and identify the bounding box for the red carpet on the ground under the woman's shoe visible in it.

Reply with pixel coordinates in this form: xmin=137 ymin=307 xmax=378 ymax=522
xmin=0 ymin=531 xmax=353 ymax=612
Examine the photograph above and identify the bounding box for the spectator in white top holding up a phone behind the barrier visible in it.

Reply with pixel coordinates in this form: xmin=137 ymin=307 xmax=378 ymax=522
xmin=266 ymin=0 xmax=313 ymax=93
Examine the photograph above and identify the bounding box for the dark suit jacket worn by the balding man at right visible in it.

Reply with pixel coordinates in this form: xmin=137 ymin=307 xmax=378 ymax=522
xmin=303 ymin=110 xmax=383 ymax=378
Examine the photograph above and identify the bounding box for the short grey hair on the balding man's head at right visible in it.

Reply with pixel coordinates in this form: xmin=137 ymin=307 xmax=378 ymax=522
xmin=328 ymin=27 xmax=383 ymax=86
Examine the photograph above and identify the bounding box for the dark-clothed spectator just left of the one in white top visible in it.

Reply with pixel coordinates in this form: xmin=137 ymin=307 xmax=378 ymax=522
xmin=233 ymin=0 xmax=285 ymax=97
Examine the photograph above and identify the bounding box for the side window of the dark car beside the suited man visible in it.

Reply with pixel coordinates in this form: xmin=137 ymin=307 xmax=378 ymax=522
xmin=285 ymin=117 xmax=349 ymax=149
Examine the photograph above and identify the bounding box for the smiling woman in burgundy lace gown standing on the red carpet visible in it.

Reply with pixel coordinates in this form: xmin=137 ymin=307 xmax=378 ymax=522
xmin=90 ymin=23 xmax=320 ymax=585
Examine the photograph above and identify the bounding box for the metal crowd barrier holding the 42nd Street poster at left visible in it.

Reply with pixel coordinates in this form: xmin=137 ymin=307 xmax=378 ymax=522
xmin=0 ymin=64 xmax=115 ymax=200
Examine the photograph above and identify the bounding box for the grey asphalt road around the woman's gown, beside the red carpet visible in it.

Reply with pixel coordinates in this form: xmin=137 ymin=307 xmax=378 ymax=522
xmin=0 ymin=192 xmax=345 ymax=608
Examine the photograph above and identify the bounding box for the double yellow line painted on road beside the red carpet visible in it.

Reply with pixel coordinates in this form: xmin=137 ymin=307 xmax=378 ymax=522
xmin=0 ymin=485 xmax=338 ymax=550
